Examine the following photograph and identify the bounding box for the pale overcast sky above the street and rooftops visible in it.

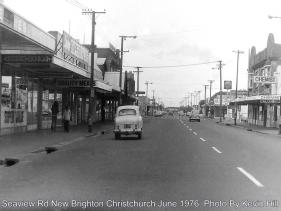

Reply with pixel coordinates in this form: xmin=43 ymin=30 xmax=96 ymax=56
xmin=4 ymin=0 xmax=281 ymax=106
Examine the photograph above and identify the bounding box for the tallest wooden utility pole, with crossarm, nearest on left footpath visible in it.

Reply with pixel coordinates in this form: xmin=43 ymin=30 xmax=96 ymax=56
xmin=82 ymin=10 xmax=105 ymax=133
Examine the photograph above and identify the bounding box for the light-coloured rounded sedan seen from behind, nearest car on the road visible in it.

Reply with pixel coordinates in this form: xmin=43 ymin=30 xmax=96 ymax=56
xmin=114 ymin=105 xmax=143 ymax=139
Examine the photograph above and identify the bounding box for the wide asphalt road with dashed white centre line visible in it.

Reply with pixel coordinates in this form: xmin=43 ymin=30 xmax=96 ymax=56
xmin=0 ymin=116 xmax=281 ymax=211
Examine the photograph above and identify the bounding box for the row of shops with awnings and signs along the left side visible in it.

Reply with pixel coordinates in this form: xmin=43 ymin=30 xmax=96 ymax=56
xmin=0 ymin=3 xmax=135 ymax=134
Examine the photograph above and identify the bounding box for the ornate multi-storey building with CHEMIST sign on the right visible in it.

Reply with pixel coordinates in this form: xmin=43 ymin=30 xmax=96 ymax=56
xmin=232 ymin=34 xmax=281 ymax=127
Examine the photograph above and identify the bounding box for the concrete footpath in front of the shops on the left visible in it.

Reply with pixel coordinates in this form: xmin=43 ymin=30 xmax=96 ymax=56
xmin=0 ymin=121 xmax=113 ymax=165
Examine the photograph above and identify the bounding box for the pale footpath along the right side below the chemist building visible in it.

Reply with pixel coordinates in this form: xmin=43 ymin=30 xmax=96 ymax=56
xmin=213 ymin=118 xmax=281 ymax=137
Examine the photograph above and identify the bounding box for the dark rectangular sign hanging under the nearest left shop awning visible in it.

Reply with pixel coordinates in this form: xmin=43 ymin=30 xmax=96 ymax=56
xmin=2 ymin=55 xmax=52 ymax=64
